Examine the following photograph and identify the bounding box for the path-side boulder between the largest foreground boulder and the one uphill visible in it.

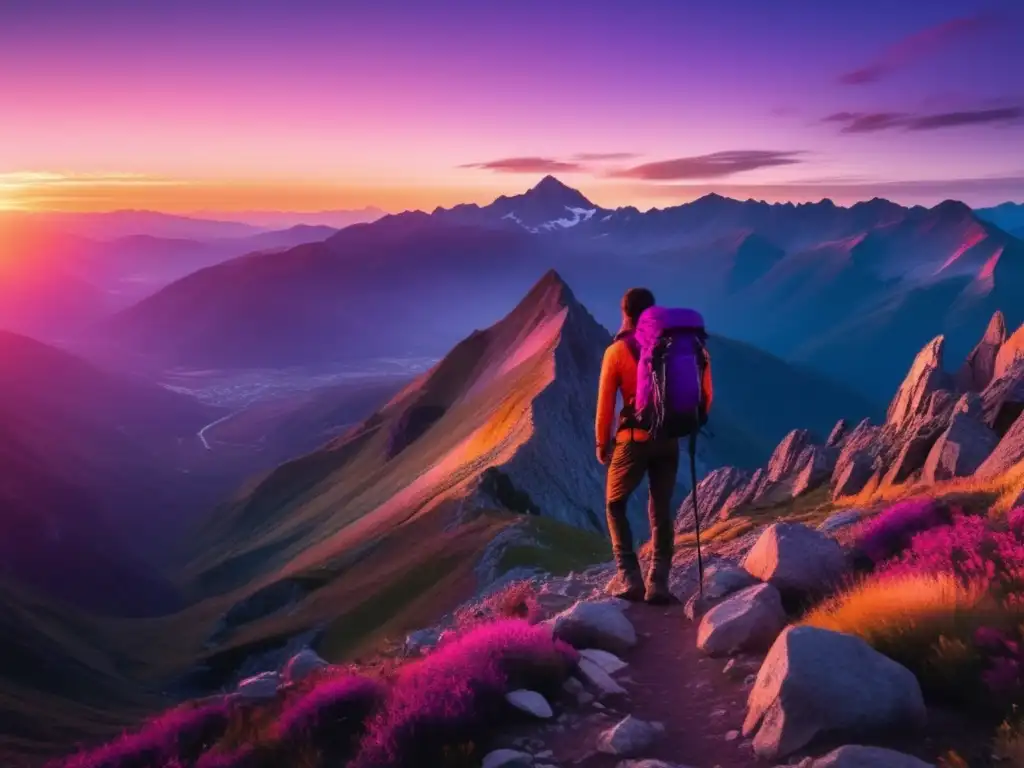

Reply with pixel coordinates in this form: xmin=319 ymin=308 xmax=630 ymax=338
xmin=697 ymin=584 xmax=786 ymax=656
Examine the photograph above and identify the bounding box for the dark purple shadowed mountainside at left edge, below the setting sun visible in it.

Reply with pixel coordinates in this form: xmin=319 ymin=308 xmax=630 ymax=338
xmin=0 ymin=333 xmax=226 ymax=613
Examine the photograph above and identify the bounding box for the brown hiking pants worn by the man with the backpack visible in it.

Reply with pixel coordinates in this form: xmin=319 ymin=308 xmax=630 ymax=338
xmin=605 ymin=439 xmax=679 ymax=560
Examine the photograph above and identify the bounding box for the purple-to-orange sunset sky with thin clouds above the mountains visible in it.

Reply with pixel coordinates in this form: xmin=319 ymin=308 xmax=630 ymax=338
xmin=0 ymin=0 xmax=1024 ymax=212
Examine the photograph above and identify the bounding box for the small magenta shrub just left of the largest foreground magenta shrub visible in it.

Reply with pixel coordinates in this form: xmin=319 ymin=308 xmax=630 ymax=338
xmin=276 ymin=675 xmax=387 ymax=764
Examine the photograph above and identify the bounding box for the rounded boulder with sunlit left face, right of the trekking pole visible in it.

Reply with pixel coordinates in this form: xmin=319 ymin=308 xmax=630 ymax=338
xmin=743 ymin=522 xmax=847 ymax=594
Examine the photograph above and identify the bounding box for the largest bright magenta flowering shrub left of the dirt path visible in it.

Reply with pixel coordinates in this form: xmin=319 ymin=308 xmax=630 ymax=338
xmin=352 ymin=620 xmax=579 ymax=768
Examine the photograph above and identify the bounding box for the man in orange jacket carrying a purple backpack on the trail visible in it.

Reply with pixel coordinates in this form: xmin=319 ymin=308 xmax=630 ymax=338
xmin=596 ymin=288 xmax=712 ymax=605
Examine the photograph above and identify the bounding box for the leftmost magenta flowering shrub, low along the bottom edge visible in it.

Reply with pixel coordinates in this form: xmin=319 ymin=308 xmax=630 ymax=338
xmin=54 ymin=701 xmax=230 ymax=768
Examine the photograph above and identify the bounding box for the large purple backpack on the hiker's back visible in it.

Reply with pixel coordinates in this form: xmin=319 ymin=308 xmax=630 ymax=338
xmin=627 ymin=306 xmax=708 ymax=438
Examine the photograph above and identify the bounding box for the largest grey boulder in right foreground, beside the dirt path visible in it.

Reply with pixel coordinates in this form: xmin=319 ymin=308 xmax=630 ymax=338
xmin=743 ymin=627 xmax=927 ymax=759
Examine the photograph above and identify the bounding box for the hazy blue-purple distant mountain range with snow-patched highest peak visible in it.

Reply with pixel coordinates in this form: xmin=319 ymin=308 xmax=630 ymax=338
xmin=105 ymin=177 xmax=1024 ymax=401
